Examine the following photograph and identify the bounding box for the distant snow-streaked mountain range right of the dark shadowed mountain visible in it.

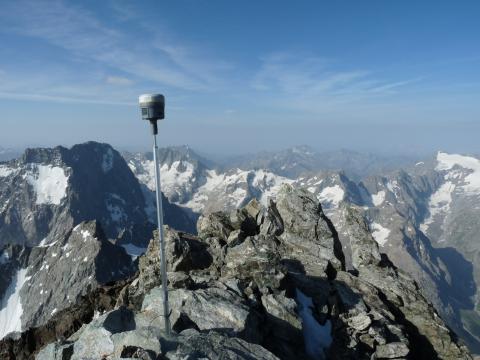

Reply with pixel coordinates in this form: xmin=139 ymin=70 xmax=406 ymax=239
xmin=124 ymin=147 xmax=480 ymax=352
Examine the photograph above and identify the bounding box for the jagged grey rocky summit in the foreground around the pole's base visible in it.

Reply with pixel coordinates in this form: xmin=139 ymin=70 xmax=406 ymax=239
xmin=0 ymin=185 xmax=472 ymax=360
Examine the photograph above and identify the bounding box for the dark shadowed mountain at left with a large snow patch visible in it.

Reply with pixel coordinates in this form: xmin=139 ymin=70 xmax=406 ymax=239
xmin=0 ymin=142 xmax=192 ymax=246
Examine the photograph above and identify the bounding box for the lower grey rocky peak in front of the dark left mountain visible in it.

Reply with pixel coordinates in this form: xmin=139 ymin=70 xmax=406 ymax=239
xmin=0 ymin=221 xmax=135 ymax=337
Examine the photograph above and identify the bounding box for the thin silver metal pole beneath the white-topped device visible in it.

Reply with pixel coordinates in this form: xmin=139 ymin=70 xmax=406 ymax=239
xmin=152 ymin=129 xmax=171 ymax=335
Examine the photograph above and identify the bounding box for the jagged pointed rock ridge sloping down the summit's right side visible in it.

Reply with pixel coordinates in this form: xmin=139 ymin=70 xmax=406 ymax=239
xmin=344 ymin=208 xmax=467 ymax=359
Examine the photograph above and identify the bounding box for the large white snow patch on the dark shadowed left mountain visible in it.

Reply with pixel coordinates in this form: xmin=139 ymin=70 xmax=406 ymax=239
xmin=24 ymin=164 xmax=68 ymax=205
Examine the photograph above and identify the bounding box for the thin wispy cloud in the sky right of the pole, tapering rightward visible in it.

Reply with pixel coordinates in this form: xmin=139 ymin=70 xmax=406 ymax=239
xmin=251 ymin=53 xmax=421 ymax=111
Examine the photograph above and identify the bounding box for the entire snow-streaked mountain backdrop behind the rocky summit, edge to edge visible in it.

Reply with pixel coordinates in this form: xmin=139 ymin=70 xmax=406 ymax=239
xmin=0 ymin=142 xmax=480 ymax=356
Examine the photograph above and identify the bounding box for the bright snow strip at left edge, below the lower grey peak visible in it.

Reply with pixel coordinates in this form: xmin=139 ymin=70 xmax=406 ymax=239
xmin=0 ymin=269 xmax=30 ymax=339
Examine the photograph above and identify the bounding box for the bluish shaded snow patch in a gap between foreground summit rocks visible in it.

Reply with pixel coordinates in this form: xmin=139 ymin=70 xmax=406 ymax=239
xmin=296 ymin=289 xmax=333 ymax=360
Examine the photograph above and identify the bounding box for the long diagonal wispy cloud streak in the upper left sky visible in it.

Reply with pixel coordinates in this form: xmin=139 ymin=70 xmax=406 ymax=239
xmin=0 ymin=0 xmax=232 ymax=102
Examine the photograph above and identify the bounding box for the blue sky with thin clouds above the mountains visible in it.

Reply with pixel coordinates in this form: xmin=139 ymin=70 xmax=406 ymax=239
xmin=0 ymin=0 xmax=480 ymax=153
